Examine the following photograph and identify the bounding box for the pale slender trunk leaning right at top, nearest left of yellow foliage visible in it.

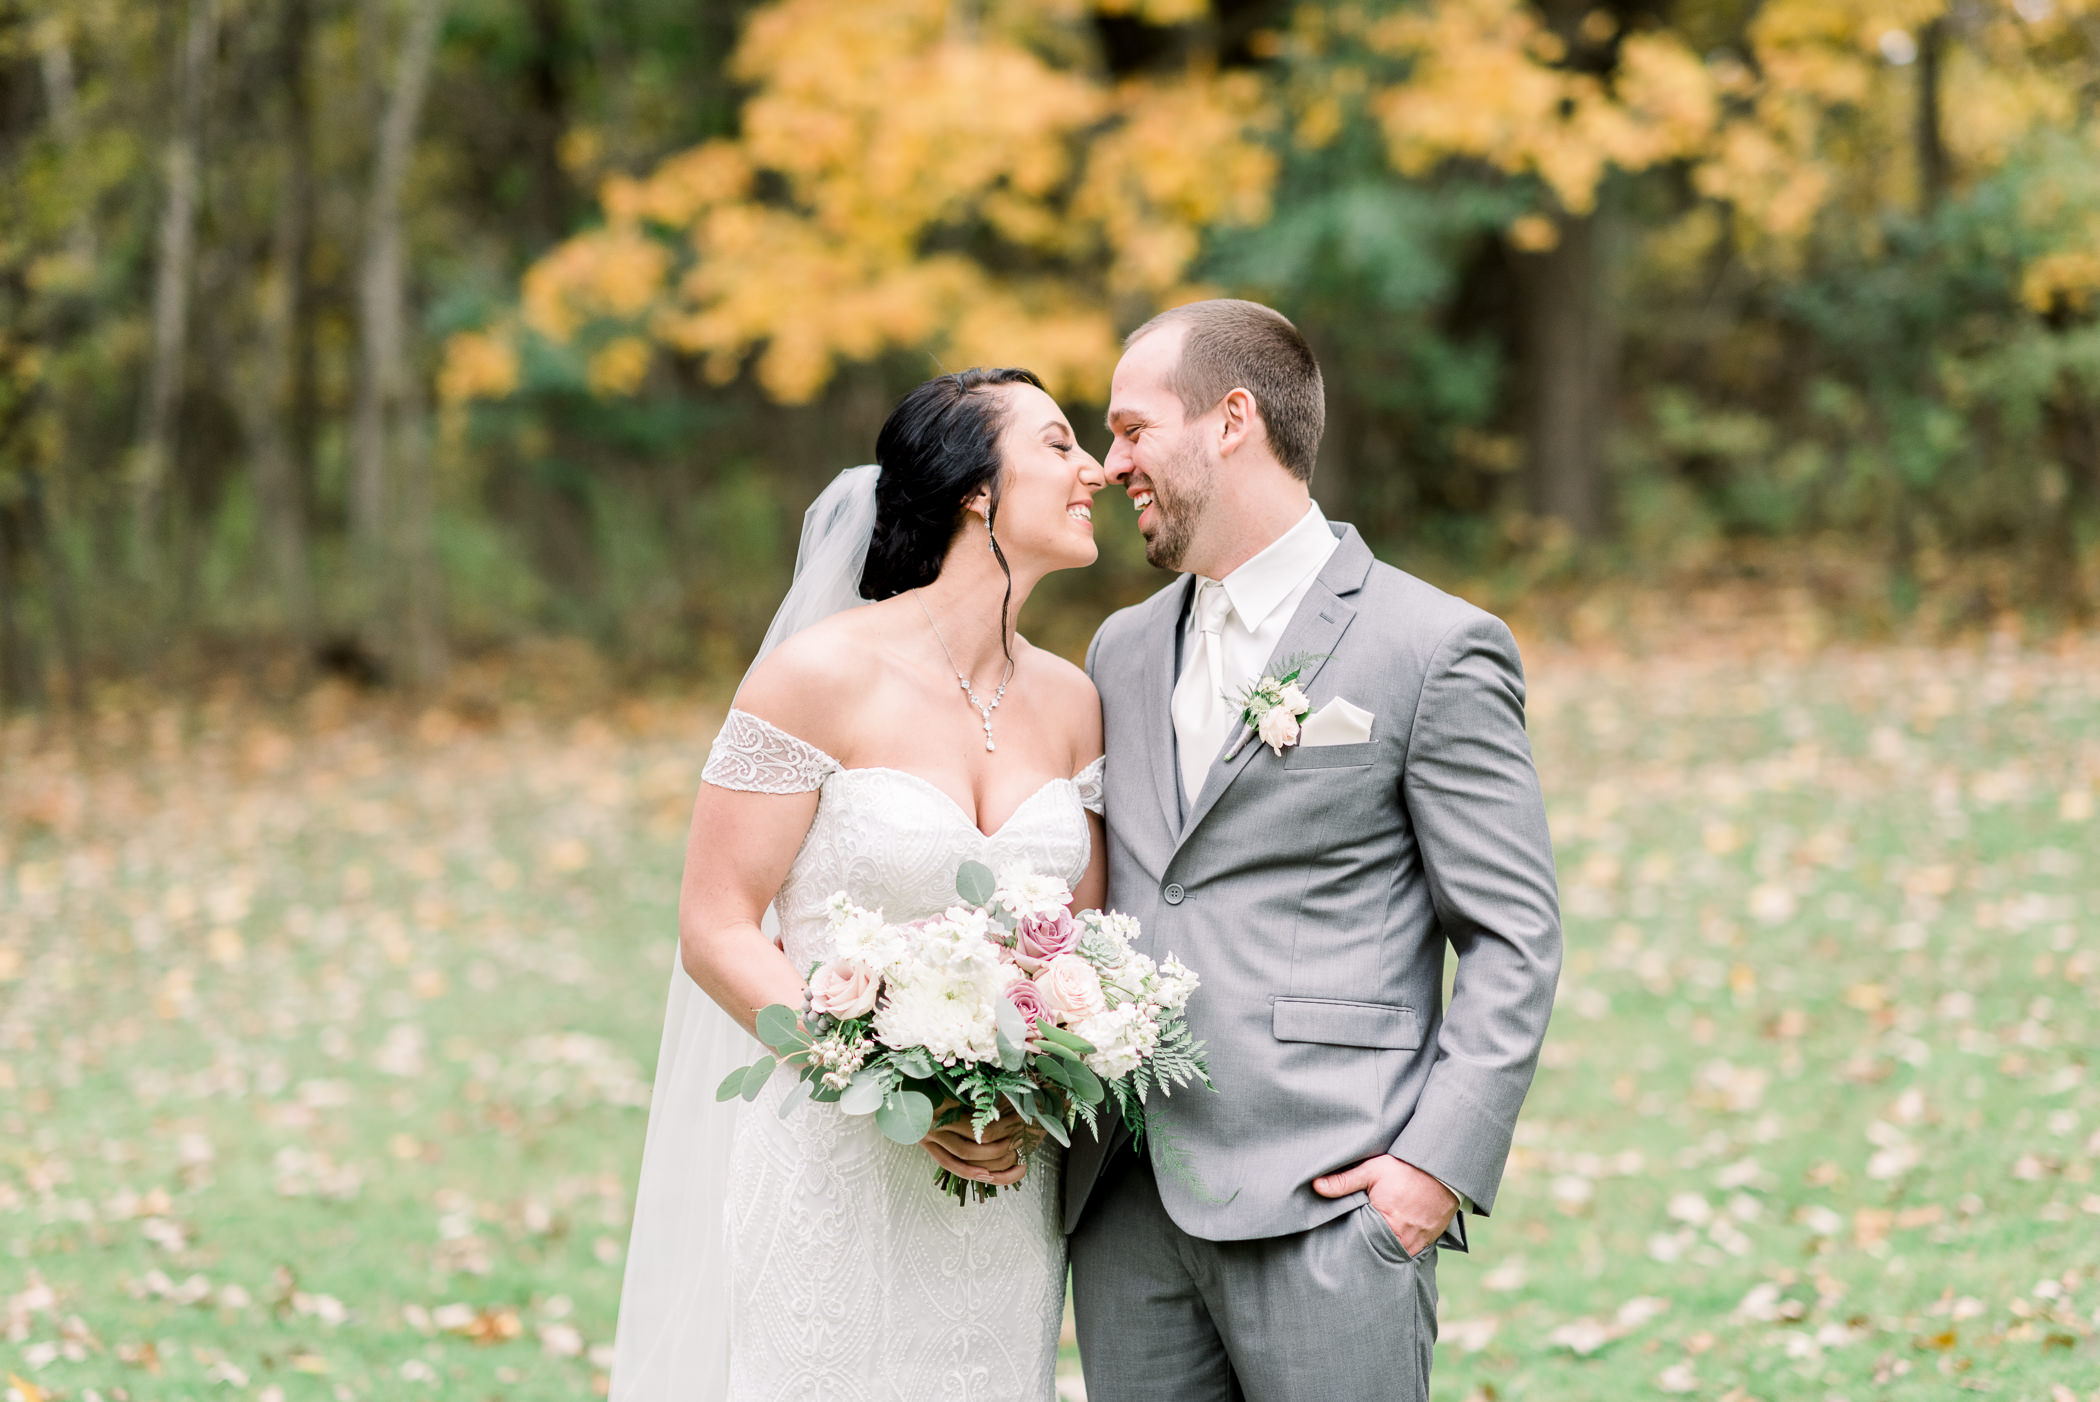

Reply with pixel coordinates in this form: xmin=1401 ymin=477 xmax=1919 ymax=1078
xmin=351 ymin=0 xmax=443 ymax=680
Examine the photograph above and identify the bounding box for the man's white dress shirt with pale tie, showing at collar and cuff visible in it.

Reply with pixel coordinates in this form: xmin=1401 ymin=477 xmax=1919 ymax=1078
xmin=1174 ymin=502 xmax=1472 ymax=1211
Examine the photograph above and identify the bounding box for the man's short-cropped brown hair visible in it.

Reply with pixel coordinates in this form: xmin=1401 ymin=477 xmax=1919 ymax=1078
xmin=1124 ymin=298 xmax=1327 ymax=483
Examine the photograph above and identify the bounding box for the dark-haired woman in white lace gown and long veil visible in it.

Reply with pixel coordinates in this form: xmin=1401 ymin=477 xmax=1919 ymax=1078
xmin=611 ymin=369 xmax=1105 ymax=1402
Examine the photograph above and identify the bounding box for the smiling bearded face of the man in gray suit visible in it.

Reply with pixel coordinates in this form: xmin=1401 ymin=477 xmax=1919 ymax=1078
xmin=1103 ymin=325 xmax=1218 ymax=569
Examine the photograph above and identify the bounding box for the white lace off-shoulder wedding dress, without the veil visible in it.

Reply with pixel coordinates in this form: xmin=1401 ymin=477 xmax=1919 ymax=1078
xmin=704 ymin=709 xmax=1100 ymax=1402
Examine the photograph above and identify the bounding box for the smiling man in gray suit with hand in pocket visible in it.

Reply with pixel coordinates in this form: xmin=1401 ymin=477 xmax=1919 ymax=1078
xmin=1065 ymin=300 xmax=1560 ymax=1402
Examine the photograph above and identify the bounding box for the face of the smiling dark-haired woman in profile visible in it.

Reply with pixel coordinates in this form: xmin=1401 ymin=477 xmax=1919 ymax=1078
xmin=993 ymin=384 xmax=1109 ymax=573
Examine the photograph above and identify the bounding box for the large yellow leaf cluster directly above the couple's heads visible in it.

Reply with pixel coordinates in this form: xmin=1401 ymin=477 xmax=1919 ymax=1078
xmin=495 ymin=0 xmax=1277 ymax=403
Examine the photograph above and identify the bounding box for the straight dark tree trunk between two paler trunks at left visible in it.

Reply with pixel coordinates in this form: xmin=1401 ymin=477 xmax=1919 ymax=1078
xmin=239 ymin=0 xmax=315 ymax=649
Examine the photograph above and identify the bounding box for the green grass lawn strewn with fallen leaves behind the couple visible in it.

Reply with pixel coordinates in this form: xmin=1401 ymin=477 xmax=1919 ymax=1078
xmin=0 ymin=640 xmax=2100 ymax=1402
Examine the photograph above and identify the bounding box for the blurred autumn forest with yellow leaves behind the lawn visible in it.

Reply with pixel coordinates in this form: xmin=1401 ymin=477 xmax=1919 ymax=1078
xmin=0 ymin=0 xmax=2100 ymax=707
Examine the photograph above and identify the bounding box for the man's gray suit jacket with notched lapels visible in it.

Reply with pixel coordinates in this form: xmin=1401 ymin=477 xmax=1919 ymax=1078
xmin=1065 ymin=525 xmax=1560 ymax=1240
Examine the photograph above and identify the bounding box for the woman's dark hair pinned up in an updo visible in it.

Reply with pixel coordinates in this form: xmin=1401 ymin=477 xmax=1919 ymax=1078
xmin=861 ymin=369 xmax=1044 ymax=598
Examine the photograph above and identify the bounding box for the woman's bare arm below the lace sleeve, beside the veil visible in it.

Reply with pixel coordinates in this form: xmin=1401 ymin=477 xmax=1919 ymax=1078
xmin=678 ymin=783 xmax=817 ymax=1035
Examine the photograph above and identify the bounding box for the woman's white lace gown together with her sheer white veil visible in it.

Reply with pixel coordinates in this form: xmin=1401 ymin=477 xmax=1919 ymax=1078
xmin=609 ymin=464 xmax=1100 ymax=1402
